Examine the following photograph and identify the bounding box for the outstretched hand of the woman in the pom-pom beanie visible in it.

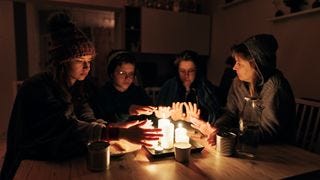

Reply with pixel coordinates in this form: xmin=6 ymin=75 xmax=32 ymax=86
xmin=119 ymin=120 xmax=162 ymax=146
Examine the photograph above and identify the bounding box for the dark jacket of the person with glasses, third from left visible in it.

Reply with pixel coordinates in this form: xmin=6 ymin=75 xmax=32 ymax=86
xmin=157 ymin=76 xmax=220 ymax=123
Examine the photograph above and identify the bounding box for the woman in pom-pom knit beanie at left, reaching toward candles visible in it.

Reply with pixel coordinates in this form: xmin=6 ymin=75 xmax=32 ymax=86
xmin=0 ymin=13 xmax=161 ymax=180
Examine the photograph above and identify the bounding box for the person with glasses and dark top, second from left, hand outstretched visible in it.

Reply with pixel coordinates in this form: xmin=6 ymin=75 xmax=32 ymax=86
xmin=92 ymin=50 xmax=155 ymax=122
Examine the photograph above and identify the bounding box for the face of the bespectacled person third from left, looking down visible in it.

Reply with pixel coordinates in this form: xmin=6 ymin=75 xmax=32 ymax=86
xmin=178 ymin=60 xmax=196 ymax=90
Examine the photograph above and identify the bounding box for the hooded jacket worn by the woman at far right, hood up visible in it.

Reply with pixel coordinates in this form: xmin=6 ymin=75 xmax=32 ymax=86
xmin=214 ymin=34 xmax=295 ymax=142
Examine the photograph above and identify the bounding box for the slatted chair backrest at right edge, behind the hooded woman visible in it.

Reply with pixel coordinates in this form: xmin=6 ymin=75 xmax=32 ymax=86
xmin=295 ymin=99 xmax=320 ymax=153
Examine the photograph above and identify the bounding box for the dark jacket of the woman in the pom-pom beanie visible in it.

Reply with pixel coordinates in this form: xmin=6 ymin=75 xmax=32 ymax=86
xmin=0 ymin=73 xmax=104 ymax=180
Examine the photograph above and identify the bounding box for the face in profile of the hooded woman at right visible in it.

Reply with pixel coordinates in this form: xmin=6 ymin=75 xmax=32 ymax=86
xmin=233 ymin=53 xmax=256 ymax=84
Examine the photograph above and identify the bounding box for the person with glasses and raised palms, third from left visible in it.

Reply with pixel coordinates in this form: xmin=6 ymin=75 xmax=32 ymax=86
xmin=157 ymin=50 xmax=220 ymax=122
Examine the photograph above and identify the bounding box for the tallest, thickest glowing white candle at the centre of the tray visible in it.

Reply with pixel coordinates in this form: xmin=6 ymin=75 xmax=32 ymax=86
xmin=158 ymin=119 xmax=174 ymax=149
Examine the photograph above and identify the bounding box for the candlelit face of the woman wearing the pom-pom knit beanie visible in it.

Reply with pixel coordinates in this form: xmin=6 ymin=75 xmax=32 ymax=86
xmin=69 ymin=55 xmax=92 ymax=85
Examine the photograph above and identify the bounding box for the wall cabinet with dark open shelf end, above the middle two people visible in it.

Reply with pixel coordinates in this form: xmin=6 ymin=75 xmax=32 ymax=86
xmin=126 ymin=7 xmax=211 ymax=55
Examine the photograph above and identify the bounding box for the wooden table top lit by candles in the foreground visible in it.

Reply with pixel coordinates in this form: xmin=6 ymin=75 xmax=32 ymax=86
xmin=15 ymin=136 xmax=320 ymax=180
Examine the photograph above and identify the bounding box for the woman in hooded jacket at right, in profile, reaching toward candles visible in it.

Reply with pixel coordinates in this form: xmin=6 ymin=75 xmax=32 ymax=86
xmin=189 ymin=34 xmax=295 ymax=148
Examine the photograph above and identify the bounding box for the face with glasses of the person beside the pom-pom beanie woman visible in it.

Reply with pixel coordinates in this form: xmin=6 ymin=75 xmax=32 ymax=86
xmin=113 ymin=63 xmax=135 ymax=92
